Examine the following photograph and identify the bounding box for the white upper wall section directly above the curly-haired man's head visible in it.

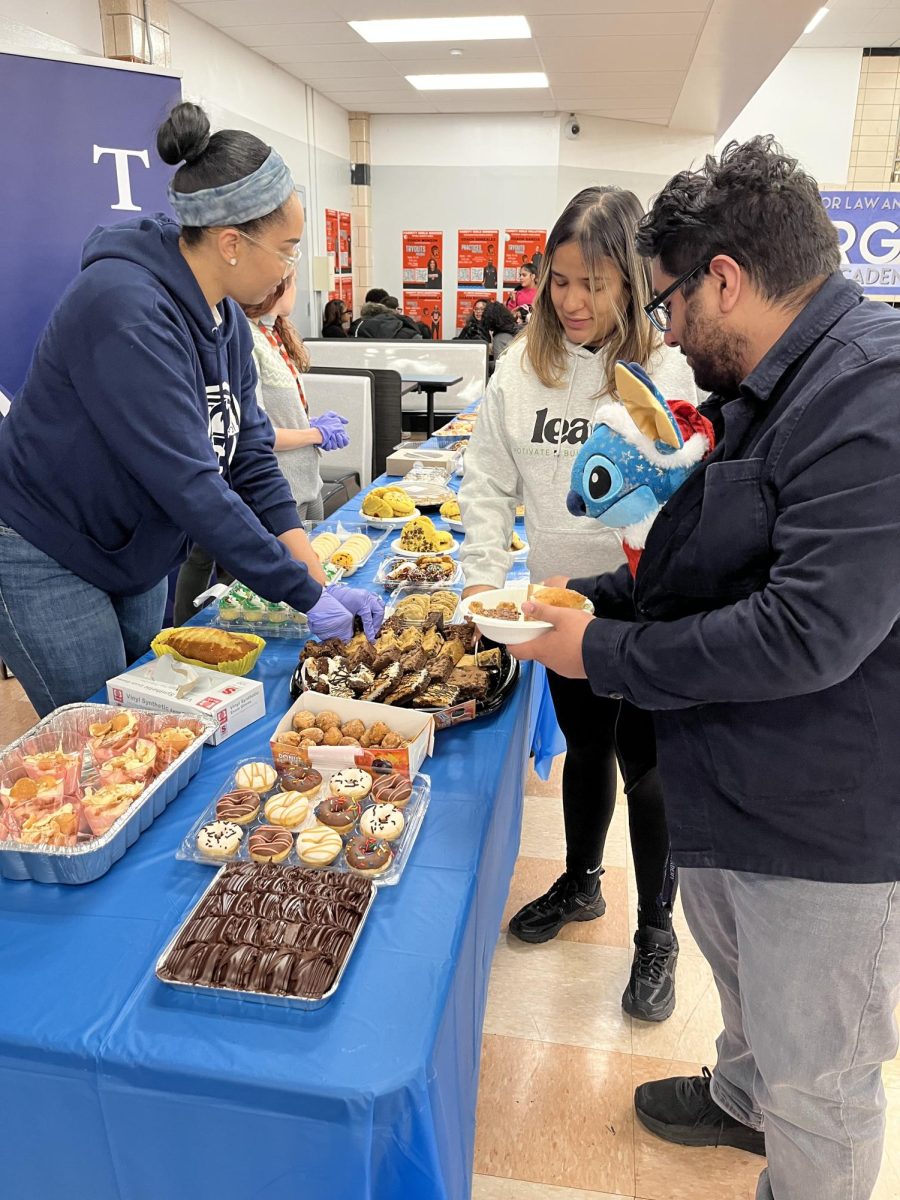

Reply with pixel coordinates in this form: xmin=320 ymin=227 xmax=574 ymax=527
xmin=718 ymin=49 xmax=862 ymax=188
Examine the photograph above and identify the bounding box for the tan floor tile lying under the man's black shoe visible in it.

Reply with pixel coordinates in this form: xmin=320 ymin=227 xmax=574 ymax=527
xmin=631 ymin=1056 xmax=764 ymax=1200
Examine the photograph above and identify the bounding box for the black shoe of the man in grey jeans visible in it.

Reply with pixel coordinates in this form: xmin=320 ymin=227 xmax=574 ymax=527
xmin=635 ymin=1067 xmax=766 ymax=1158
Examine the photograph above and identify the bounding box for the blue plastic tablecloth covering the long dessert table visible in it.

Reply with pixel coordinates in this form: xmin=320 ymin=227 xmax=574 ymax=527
xmin=0 ymin=472 xmax=546 ymax=1200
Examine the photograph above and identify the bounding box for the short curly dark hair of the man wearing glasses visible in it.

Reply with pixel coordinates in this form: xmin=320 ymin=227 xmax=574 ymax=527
xmin=637 ymin=133 xmax=840 ymax=300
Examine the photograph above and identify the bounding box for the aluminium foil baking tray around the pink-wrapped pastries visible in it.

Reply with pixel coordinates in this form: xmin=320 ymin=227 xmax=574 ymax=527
xmin=0 ymin=704 xmax=215 ymax=883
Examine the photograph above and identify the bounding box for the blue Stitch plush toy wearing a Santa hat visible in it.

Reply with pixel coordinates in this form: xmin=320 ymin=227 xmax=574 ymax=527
xmin=566 ymin=362 xmax=715 ymax=574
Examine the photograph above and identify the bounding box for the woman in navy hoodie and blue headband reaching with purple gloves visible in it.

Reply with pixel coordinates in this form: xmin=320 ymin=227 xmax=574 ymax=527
xmin=0 ymin=104 xmax=383 ymax=714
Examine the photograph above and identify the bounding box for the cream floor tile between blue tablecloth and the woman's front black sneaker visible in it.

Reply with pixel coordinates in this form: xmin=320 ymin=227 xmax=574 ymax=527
xmin=485 ymin=934 xmax=631 ymax=1056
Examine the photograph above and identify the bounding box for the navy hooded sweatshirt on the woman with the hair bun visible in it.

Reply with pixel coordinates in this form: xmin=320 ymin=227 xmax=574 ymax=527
xmin=0 ymin=215 xmax=322 ymax=611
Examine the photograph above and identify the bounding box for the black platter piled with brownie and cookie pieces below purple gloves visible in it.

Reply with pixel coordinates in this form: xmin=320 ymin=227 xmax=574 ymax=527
xmin=290 ymin=606 xmax=520 ymax=728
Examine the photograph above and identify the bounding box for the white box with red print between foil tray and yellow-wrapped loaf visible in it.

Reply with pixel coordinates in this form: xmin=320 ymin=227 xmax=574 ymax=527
xmin=107 ymin=655 xmax=265 ymax=745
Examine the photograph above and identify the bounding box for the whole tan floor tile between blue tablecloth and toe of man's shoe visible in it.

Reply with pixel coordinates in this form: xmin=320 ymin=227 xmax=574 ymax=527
xmin=475 ymin=1036 xmax=635 ymax=1200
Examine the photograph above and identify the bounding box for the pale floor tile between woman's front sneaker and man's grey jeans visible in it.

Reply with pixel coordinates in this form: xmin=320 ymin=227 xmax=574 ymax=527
xmin=631 ymin=955 xmax=721 ymax=1067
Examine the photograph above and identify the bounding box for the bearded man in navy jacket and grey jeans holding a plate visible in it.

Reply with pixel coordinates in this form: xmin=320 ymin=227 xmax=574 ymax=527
xmin=521 ymin=138 xmax=900 ymax=1200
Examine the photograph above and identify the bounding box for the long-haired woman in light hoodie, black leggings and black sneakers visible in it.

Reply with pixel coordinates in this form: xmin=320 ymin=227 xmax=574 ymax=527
xmin=460 ymin=187 xmax=696 ymax=1021
